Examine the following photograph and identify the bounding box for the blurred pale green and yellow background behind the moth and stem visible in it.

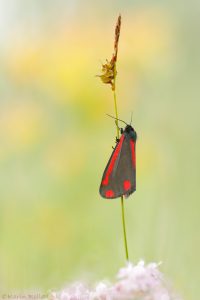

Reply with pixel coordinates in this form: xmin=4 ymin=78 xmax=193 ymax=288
xmin=0 ymin=0 xmax=200 ymax=300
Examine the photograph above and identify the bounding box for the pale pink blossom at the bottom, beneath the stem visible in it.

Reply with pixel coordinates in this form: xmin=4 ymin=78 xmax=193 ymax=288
xmin=50 ymin=261 xmax=181 ymax=300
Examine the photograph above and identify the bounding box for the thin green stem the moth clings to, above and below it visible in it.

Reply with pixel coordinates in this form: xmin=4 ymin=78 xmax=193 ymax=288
xmin=113 ymin=63 xmax=129 ymax=261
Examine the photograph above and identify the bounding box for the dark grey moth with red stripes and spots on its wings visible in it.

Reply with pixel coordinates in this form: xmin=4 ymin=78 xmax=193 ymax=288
xmin=99 ymin=125 xmax=137 ymax=199
